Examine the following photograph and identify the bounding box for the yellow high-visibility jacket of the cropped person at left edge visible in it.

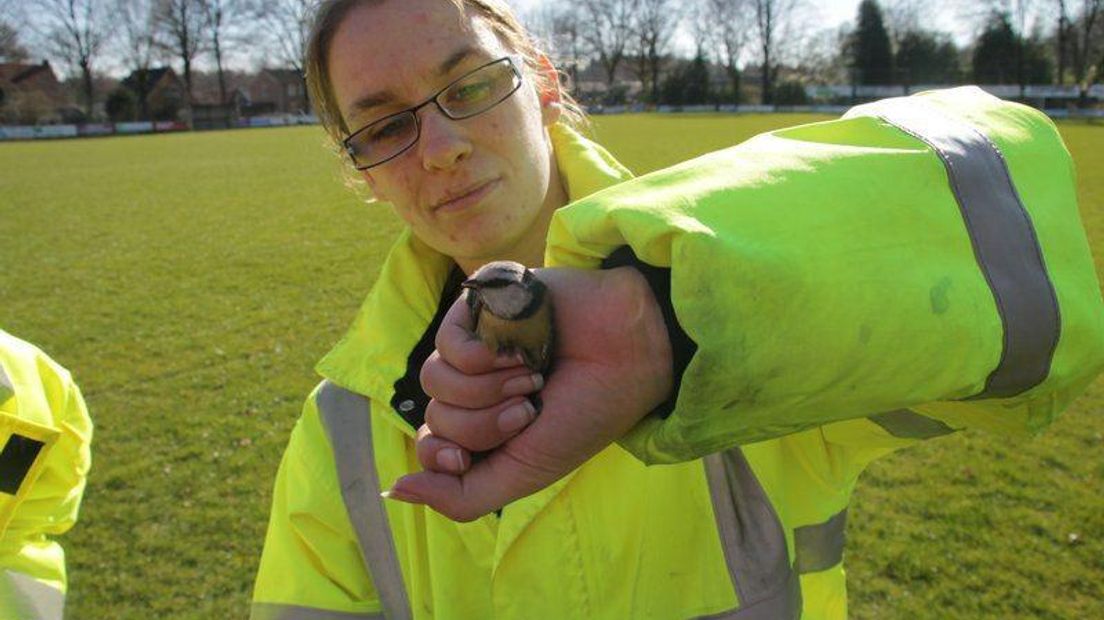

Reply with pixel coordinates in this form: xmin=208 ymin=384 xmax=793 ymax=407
xmin=0 ymin=330 xmax=92 ymax=620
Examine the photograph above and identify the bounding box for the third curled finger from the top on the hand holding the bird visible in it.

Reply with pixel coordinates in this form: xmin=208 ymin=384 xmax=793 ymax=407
xmin=418 ymin=396 xmax=537 ymax=447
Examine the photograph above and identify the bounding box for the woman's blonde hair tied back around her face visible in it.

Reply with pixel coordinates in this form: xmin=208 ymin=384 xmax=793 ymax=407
xmin=304 ymin=0 xmax=587 ymax=150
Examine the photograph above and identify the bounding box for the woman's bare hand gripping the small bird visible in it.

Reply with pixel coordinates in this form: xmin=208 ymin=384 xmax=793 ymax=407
xmin=388 ymin=262 xmax=672 ymax=521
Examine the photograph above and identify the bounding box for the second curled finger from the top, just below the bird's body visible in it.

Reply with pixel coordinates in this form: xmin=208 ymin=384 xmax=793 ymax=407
xmin=421 ymin=344 xmax=544 ymax=409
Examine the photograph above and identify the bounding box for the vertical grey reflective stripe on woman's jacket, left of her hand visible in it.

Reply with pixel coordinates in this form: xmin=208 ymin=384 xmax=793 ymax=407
xmin=316 ymin=382 xmax=411 ymax=620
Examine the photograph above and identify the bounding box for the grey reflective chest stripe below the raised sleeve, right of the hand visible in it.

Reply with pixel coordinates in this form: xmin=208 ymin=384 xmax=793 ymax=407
xmin=704 ymin=448 xmax=802 ymax=620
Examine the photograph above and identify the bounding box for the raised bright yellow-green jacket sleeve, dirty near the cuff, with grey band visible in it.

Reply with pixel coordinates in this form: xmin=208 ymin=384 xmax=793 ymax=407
xmin=545 ymin=89 xmax=1104 ymax=463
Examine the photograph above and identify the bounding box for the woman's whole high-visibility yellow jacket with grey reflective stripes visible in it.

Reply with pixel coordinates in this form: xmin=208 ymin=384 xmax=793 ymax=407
xmin=253 ymin=92 xmax=1102 ymax=620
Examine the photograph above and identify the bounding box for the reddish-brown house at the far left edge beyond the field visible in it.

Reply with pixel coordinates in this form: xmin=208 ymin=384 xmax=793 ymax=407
xmin=0 ymin=61 xmax=72 ymax=125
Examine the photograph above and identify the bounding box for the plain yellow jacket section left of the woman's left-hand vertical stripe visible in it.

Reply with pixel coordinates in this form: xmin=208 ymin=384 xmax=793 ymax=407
xmin=251 ymin=389 xmax=380 ymax=620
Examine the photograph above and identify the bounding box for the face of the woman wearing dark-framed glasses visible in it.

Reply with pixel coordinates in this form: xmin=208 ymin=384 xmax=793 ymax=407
xmin=329 ymin=0 xmax=565 ymax=271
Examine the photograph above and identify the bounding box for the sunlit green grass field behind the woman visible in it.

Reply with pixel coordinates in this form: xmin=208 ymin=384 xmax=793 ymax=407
xmin=0 ymin=115 xmax=1104 ymax=620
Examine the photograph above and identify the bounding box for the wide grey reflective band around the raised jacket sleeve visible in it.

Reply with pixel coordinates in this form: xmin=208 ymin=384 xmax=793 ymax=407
xmin=870 ymin=97 xmax=1061 ymax=398
